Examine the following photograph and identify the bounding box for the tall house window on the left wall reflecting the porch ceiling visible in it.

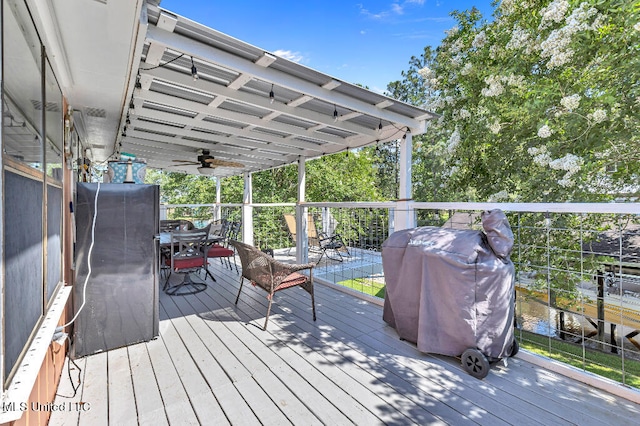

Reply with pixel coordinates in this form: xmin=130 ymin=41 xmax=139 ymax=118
xmin=0 ymin=0 xmax=64 ymax=388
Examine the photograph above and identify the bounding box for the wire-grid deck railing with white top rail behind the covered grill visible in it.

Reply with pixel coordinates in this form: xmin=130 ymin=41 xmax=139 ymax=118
xmin=166 ymin=202 xmax=640 ymax=388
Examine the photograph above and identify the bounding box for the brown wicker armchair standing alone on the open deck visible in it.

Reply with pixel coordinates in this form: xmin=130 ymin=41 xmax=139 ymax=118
xmin=230 ymin=240 xmax=316 ymax=330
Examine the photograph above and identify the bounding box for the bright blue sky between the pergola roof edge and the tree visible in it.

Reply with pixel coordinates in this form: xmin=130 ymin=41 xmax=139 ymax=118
xmin=160 ymin=0 xmax=493 ymax=92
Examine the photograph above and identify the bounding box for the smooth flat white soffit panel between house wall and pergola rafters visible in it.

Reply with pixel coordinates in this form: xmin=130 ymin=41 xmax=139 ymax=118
xmin=27 ymin=0 xmax=146 ymax=160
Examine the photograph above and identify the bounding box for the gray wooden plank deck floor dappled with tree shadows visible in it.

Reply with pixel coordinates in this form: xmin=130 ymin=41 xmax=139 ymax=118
xmin=49 ymin=262 xmax=640 ymax=426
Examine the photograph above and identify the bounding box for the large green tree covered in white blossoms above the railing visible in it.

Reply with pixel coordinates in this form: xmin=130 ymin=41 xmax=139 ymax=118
xmin=389 ymin=0 xmax=640 ymax=202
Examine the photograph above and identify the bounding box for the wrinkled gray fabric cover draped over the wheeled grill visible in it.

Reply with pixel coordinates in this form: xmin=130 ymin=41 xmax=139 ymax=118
xmin=382 ymin=210 xmax=515 ymax=358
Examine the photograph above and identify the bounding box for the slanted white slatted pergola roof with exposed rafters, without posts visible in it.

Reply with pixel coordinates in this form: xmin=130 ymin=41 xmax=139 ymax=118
xmin=119 ymin=5 xmax=434 ymax=176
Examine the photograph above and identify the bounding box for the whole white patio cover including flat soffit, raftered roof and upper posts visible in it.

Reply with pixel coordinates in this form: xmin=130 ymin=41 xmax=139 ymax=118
xmin=29 ymin=0 xmax=436 ymax=253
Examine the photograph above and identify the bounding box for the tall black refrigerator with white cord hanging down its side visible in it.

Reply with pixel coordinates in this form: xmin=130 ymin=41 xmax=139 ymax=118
xmin=73 ymin=183 xmax=160 ymax=357
